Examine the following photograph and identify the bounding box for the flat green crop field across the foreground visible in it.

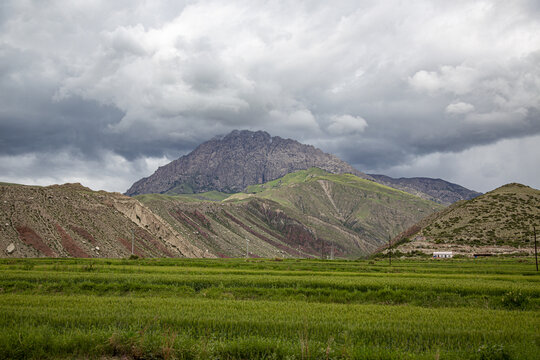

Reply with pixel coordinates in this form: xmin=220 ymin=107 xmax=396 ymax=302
xmin=0 ymin=258 xmax=540 ymax=359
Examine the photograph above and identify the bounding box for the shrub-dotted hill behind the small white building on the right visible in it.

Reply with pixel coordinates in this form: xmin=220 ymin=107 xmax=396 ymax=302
xmin=393 ymin=183 xmax=540 ymax=254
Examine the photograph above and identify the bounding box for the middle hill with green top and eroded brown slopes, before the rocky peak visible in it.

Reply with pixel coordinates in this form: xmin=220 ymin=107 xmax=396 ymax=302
xmin=136 ymin=168 xmax=442 ymax=258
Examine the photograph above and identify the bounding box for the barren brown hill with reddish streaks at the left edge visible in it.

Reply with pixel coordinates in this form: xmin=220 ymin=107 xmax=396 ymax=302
xmin=0 ymin=183 xmax=208 ymax=258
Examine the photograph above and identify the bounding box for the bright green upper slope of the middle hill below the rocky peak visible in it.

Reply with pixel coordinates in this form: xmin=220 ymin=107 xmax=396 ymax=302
xmin=227 ymin=169 xmax=443 ymax=242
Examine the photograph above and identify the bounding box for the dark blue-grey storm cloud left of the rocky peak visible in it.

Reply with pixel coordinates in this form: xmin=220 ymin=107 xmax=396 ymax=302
xmin=0 ymin=46 xmax=197 ymax=160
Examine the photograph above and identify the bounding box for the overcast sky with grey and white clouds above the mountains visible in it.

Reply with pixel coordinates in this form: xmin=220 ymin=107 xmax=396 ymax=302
xmin=0 ymin=0 xmax=540 ymax=192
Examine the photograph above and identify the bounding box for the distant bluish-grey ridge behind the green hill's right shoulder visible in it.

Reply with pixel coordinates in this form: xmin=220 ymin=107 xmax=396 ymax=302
xmin=369 ymin=174 xmax=482 ymax=205
